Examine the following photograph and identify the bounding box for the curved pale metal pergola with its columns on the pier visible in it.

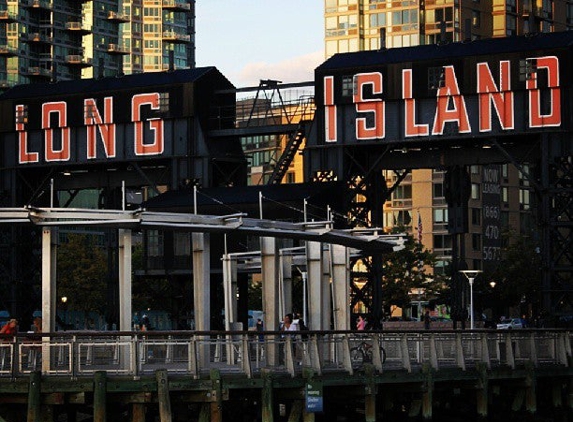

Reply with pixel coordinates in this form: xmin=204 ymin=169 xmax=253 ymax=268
xmin=0 ymin=208 xmax=404 ymax=340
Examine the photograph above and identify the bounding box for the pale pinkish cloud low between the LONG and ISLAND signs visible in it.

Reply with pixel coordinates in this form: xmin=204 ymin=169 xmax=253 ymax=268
xmin=231 ymin=51 xmax=324 ymax=88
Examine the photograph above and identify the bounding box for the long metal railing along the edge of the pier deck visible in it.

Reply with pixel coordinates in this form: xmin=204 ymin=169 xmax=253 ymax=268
xmin=0 ymin=330 xmax=572 ymax=378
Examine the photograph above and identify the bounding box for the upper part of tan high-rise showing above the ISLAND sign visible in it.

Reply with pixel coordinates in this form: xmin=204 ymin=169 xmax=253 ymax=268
xmin=325 ymin=0 xmax=573 ymax=58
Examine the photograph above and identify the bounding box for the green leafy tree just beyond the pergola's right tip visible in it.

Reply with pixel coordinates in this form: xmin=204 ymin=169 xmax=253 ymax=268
xmin=382 ymin=228 xmax=446 ymax=313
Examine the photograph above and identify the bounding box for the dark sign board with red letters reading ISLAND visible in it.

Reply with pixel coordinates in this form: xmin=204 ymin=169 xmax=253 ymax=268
xmin=316 ymin=34 xmax=573 ymax=144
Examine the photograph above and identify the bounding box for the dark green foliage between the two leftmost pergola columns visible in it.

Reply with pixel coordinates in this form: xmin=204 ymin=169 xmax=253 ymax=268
xmin=57 ymin=233 xmax=107 ymax=312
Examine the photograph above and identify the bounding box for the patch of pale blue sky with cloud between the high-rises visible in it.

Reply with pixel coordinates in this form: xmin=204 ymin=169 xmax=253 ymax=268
xmin=195 ymin=0 xmax=324 ymax=88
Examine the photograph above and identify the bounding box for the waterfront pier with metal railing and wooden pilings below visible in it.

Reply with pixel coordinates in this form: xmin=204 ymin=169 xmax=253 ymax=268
xmin=0 ymin=330 xmax=573 ymax=422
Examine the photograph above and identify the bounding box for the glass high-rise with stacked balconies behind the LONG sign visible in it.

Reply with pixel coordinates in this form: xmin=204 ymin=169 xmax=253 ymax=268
xmin=0 ymin=0 xmax=195 ymax=90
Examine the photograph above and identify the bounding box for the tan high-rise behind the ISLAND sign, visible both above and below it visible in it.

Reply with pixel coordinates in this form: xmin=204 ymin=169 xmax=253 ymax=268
xmin=324 ymin=0 xmax=560 ymax=272
